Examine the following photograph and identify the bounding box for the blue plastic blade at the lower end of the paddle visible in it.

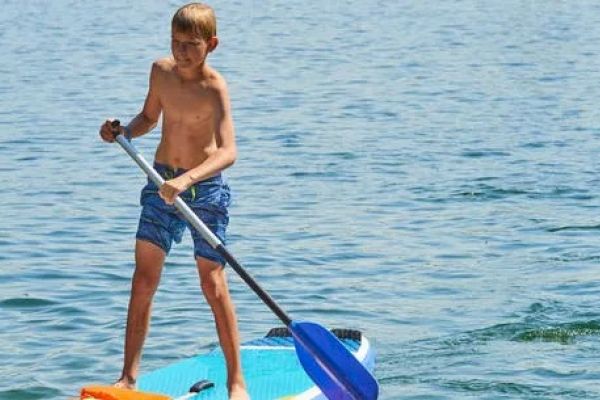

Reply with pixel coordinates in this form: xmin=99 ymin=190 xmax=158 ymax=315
xmin=288 ymin=321 xmax=379 ymax=400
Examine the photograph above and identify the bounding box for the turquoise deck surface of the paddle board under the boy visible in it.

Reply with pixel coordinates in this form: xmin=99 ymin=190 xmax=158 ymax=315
xmin=138 ymin=327 xmax=374 ymax=400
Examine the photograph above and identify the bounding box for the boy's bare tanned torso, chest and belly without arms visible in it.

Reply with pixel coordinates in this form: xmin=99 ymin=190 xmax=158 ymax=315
xmin=155 ymin=58 xmax=219 ymax=169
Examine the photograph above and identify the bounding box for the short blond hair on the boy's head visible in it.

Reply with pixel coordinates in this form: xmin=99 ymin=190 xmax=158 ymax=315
xmin=171 ymin=3 xmax=217 ymax=40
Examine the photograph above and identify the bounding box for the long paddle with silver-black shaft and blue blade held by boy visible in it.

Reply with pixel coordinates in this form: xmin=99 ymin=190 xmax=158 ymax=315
xmin=108 ymin=120 xmax=379 ymax=400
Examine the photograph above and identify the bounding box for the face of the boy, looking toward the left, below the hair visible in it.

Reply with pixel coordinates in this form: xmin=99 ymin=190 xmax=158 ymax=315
xmin=171 ymin=30 xmax=218 ymax=68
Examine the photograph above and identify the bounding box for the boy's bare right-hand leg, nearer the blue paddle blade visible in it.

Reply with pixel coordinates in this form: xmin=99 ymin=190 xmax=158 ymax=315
xmin=196 ymin=257 xmax=249 ymax=400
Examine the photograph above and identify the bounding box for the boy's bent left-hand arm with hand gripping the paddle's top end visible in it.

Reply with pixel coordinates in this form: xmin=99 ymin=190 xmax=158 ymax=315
xmin=100 ymin=62 xmax=162 ymax=143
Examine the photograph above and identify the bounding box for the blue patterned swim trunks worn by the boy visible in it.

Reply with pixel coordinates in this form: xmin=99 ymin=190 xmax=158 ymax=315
xmin=136 ymin=163 xmax=231 ymax=265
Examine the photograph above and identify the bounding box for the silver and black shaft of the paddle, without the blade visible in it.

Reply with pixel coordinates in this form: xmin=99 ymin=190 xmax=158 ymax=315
xmin=115 ymin=134 xmax=292 ymax=326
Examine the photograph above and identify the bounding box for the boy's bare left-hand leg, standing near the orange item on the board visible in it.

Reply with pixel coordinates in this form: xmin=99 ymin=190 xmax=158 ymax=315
xmin=115 ymin=240 xmax=165 ymax=389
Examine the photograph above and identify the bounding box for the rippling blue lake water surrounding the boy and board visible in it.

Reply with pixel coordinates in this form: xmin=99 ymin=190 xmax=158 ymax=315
xmin=0 ymin=0 xmax=600 ymax=400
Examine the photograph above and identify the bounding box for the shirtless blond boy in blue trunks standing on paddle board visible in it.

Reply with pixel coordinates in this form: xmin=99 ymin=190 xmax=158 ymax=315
xmin=100 ymin=3 xmax=249 ymax=400
